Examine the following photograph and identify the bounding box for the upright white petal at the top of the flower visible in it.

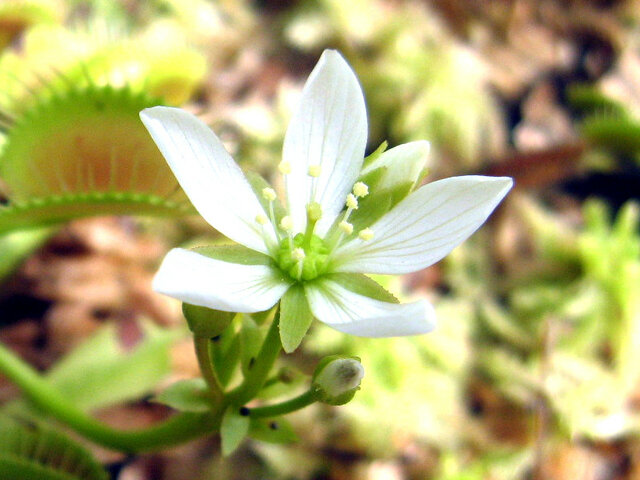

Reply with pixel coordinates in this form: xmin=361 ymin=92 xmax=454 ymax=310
xmin=283 ymin=50 xmax=367 ymax=235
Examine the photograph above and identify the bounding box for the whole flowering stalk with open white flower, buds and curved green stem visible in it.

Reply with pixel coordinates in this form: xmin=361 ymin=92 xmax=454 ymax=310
xmin=0 ymin=50 xmax=512 ymax=464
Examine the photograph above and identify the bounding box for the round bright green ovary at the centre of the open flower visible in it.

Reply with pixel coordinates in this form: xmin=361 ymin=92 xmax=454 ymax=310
xmin=277 ymin=233 xmax=329 ymax=280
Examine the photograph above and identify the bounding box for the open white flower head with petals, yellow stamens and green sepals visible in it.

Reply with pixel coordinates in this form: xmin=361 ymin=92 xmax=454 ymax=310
xmin=140 ymin=50 xmax=512 ymax=351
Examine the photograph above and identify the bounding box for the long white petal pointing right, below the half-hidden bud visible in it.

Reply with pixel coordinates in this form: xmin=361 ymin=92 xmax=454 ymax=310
xmin=334 ymin=175 xmax=513 ymax=274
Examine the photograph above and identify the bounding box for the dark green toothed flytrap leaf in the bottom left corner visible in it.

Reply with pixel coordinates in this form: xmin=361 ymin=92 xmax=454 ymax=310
xmin=0 ymin=416 xmax=108 ymax=480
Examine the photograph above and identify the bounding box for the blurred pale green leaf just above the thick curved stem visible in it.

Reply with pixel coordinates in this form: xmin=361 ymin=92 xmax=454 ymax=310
xmin=46 ymin=323 xmax=182 ymax=411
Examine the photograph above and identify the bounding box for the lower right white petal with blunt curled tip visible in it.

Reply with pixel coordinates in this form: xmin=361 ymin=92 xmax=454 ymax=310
xmin=305 ymin=280 xmax=436 ymax=337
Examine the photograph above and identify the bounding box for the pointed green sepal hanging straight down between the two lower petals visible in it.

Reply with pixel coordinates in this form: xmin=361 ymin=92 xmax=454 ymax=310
xmin=280 ymin=285 xmax=313 ymax=353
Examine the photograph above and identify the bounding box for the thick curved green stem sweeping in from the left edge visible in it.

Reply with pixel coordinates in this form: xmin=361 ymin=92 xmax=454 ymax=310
xmin=0 ymin=344 xmax=221 ymax=453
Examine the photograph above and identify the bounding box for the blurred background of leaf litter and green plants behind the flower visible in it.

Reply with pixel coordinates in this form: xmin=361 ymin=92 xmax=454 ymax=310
xmin=0 ymin=0 xmax=640 ymax=480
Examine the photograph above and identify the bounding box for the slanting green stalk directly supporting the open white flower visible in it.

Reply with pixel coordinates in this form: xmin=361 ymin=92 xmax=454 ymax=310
xmin=227 ymin=309 xmax=282 ymax=405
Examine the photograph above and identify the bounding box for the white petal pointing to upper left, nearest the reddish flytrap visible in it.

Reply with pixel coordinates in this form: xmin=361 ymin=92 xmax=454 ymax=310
xmin=140 ymin=107 xmax=275 ymax=253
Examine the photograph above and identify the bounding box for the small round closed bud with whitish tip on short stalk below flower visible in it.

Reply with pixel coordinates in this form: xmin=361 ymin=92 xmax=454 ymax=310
xmin=313 ymin=355 xmax=364 ymax=405
